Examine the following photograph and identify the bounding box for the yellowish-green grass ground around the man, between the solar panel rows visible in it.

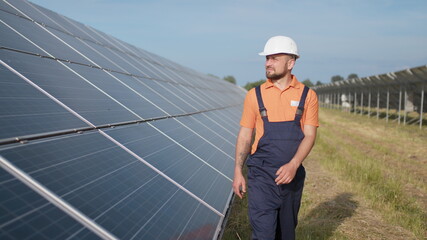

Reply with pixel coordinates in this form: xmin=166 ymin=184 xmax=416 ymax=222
xmin=222 ymin=109 xmax=427 ymax=240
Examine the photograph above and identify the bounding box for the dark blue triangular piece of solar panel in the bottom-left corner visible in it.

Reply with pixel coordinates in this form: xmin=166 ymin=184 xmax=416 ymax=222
xmin=0 ymin=168 xmax=100 ymax=240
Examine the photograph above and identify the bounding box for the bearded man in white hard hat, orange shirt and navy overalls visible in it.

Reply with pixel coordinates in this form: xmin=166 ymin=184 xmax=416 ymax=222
xmin=233 ymin=36 xmax=319 ymax=240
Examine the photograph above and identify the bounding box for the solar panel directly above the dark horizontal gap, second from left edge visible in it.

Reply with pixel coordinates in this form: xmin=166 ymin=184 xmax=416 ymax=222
xmin=0 ymin=51 xmax=139 ymax=125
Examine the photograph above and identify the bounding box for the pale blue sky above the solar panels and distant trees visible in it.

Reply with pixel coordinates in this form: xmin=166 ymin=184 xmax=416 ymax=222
xmin=31 ymin=0 xmax=427 ymax=85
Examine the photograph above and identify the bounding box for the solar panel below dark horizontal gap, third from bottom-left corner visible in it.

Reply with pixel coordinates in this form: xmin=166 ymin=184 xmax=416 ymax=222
xmin=102 ymin=124 xmax=232 ymax=212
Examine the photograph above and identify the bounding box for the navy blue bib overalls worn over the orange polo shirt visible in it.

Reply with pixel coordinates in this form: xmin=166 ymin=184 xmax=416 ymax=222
xmin=247 ymin=86 xmax=309 ymax=240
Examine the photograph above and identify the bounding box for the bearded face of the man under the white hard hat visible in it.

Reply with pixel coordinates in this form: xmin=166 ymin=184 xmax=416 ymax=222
xmin=265 ymin=53 xmax=294 ymax=80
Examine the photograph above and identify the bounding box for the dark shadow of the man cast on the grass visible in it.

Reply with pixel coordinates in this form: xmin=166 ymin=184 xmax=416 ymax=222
xmin=297 ymin=193 xmax=358 ymax=239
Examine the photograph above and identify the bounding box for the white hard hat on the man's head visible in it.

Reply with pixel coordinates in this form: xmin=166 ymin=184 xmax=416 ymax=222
xmin=259 ymin=36 xmax=299 ymax=58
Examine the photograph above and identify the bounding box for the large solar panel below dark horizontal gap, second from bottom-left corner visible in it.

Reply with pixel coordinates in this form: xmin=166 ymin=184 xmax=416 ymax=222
xmin=0 ymin=132 xmax=219 ymax=239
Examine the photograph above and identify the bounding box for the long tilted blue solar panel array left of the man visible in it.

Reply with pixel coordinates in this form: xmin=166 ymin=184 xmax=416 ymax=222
xmin=0 ymin=0 xmax=245 ymax=239
